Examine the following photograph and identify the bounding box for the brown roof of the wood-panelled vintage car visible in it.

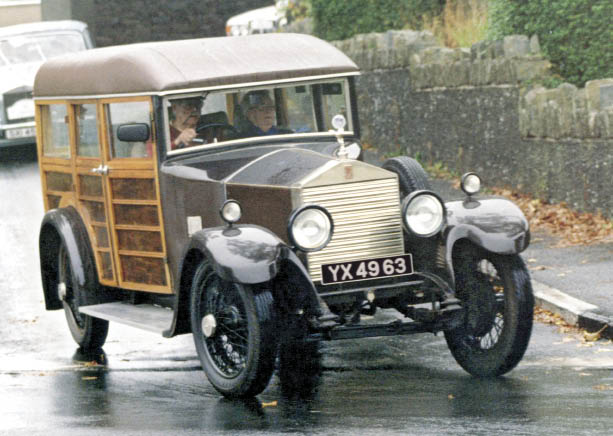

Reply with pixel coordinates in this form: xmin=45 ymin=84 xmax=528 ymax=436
xmin=34 ymin=33 xmax=358 ymax=97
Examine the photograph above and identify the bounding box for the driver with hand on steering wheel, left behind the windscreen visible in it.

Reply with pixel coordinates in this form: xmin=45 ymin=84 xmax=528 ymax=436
xmin=169 ymin=97 xmax=202 ymax=150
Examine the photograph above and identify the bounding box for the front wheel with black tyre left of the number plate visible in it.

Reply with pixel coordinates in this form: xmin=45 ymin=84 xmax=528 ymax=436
xmin=190 ymin=261 xmax=278 ymax=398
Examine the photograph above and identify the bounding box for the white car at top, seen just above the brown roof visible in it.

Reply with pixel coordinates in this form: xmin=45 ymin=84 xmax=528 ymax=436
xmin=226 ymin=0 xmax=287 ymax=36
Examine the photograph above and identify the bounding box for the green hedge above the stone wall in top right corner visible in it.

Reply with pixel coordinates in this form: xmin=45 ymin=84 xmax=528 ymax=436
xmin=489 ymin=0 xmax=613 ymax=86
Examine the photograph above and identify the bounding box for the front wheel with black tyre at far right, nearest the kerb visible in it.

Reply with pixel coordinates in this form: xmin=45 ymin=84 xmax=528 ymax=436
xmin=445 ymin=245 xmax=534 ymax=377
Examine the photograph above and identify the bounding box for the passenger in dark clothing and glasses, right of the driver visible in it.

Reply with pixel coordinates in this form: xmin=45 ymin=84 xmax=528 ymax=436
xmin=240 ymin=90 xmax=293 ymax=138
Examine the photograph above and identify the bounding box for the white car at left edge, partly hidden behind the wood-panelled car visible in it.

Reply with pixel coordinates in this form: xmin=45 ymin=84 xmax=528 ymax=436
xmin=0 ymin=20 xmax=93 ymax=147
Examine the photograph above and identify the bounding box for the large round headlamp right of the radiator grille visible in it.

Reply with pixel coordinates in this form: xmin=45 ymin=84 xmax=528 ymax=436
xmin=402 ymin=191 xmax=445 ymax=238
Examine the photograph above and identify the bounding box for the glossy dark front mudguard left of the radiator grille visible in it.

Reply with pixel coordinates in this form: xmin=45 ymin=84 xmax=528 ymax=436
xmin=169 ymin=225 xmax=321 ymax=336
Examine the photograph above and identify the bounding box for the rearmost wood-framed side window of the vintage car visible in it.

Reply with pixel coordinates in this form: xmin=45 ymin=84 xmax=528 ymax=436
xmin=41 ymin=104 xmax=70 ymax=159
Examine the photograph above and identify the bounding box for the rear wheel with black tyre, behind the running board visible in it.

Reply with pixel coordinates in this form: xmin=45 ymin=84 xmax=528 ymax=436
xmin=57 ymin=243 xmax=109 ymax=351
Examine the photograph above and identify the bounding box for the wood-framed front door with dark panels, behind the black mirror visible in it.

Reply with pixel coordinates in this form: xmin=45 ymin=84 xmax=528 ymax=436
xmin=101 ymin=97 xmax=172 ymax=293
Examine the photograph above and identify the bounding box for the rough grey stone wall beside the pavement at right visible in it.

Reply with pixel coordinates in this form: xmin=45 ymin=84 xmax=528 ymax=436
xmin=334 ymin=31 xmax=613 ymax=217
